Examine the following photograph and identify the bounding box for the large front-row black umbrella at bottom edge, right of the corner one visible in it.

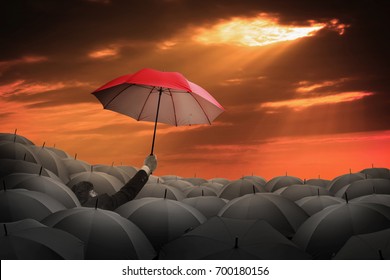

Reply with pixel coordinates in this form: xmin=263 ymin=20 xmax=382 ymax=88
xmin=42 ymin=207 xmax=156 ymax=260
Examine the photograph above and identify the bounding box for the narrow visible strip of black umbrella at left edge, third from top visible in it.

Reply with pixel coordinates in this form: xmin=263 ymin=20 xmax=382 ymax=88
xmin=0 ymin=159 xmax=62 ymax=182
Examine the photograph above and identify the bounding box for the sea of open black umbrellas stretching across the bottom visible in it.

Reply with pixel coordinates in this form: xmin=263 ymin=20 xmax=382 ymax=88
xmin=0 ymin=133 xmax=390 ymax=260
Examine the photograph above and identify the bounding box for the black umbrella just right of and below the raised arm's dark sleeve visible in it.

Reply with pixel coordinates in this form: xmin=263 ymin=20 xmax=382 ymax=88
xmin=115 ymin=198 xmax=206 ymax=250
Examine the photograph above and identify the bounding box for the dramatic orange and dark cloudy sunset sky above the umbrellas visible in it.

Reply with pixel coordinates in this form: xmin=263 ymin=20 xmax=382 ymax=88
xmin=0 ymin=0 xmax=390 ymax=180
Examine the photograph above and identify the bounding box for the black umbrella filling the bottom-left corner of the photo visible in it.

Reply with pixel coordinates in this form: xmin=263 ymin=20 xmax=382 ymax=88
xmin=0 ymin=219 xmax=84 ymax=260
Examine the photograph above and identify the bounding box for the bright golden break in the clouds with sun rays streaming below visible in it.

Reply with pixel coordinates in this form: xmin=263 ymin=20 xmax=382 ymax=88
xmin=194 ymin=13 xmax=326 ymax=47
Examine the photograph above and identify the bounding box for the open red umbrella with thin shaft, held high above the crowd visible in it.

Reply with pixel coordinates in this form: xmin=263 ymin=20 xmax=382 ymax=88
xmin=92 ymin=69 xmax=224 ymax=154
